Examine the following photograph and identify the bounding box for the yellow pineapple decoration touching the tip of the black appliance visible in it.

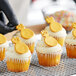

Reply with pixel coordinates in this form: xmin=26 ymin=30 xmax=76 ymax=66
xmin=16 ymin=24 xmax=34 ymax=39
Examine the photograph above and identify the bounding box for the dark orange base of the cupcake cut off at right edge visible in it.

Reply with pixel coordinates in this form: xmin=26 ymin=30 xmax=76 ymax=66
xmin=66 ymin=43 xmax=76 ymax=58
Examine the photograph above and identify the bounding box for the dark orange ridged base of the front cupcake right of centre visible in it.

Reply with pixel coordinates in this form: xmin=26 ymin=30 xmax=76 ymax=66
xmin=37 ymin=52 xmax=61 ymax=66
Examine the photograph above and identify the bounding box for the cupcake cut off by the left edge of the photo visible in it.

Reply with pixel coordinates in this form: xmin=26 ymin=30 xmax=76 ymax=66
xmin=0 ymin=34 xmax=8 ymax=61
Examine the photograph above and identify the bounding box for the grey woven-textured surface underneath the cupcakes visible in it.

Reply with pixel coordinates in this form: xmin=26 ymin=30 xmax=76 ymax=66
xmin=0 ymin=34 xmax=76 ymax=76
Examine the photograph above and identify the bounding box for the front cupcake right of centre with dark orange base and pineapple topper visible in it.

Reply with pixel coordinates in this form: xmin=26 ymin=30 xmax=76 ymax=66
xmin=36 ymin=30 xmax=62 ymax=66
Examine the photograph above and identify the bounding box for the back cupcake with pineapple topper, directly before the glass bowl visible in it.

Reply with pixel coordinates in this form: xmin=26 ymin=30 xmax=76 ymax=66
xmin=45 ymin=17 xmax=66 ymax=46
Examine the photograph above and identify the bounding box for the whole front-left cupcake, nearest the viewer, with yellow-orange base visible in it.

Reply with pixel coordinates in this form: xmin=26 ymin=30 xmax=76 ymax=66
xmin=6 ymin=37 xmax=31 ymax=72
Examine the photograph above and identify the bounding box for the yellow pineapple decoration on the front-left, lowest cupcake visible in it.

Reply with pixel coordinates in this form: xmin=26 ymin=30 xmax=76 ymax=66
xmin=11 ymin=37 xmax=29 ymax=54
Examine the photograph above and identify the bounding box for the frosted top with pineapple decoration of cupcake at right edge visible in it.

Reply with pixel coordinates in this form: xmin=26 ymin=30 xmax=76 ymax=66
xmin=65 ymin=23 xmax=76 ymax=45
